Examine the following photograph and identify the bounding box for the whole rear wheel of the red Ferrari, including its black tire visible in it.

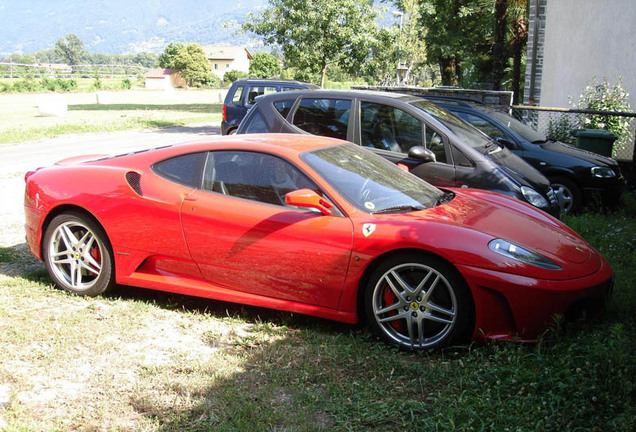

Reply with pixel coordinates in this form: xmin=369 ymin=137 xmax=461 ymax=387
xmin=42 ymin=212 xmax=115 ymax=297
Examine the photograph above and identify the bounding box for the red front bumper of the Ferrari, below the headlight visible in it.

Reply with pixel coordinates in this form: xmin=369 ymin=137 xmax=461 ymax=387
xmin=458 ymin=259 xmax=613 ymax=340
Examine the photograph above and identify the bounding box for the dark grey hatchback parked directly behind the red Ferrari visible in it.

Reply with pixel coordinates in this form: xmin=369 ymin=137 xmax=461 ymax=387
xmin=237 ymin=90 xmax=560 ymax=217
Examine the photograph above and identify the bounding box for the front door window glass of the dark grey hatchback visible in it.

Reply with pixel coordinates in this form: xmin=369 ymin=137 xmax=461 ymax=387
xmin=360 ymin=102 xmax=422 ymax=153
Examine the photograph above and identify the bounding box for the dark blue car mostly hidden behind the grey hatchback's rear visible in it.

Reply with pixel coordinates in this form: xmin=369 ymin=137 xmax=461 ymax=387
xmin=221 ymin=79 xmax=318 ymax=135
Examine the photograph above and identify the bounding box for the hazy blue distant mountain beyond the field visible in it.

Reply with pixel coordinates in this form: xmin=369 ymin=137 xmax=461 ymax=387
xmin=0 ymin=0 xmax=267 ymax=57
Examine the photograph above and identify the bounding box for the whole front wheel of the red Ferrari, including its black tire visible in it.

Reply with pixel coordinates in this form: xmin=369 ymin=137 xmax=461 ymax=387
xmin=365 ymin=255 xmax=474 ymax=350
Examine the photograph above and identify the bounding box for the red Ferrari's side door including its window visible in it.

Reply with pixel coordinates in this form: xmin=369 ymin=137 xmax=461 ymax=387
xmin=181 ymin=151 xmax=353 ymax=308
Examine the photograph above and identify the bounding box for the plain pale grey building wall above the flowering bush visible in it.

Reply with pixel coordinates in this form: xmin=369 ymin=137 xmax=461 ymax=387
xmin=531 ymin=0 xmax=636 ymax=109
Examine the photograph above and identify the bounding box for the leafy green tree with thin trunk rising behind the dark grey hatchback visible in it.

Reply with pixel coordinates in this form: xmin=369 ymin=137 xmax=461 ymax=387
xmin=243 ymin=0 xmax=377 ymax=87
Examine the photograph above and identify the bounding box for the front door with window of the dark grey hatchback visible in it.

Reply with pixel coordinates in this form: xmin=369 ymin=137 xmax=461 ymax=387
xmin=356 ymin=100 xmax=460 ymax=187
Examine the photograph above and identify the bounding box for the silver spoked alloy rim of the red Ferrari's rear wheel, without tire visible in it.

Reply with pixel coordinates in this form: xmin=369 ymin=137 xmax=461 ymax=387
xmin=48 ymin=221 xmax=105 ymax=292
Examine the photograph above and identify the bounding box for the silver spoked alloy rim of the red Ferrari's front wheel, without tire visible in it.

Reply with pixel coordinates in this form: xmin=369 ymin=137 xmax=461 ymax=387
xmin=372 ymin=263 xmax=457 ymax=349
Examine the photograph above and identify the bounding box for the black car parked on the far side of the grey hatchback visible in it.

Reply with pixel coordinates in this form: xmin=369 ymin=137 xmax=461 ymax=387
xmin=426 ymin=96 xmax=625 ymax=213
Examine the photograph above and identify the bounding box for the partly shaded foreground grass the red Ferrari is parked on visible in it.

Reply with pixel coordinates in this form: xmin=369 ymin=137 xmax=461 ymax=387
xmin=0 ymin=195 xmax=636 ymax=432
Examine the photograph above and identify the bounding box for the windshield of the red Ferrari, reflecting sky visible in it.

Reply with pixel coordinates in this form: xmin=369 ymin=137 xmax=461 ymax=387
xmin=301 ymin=144 xmax=444 ymax=213
